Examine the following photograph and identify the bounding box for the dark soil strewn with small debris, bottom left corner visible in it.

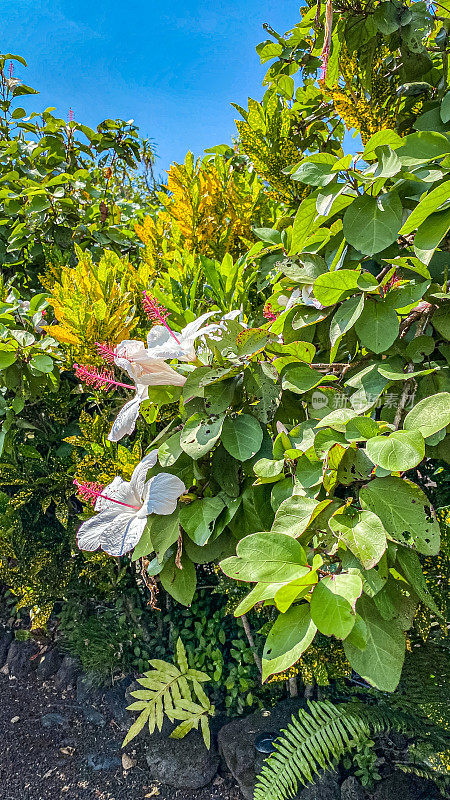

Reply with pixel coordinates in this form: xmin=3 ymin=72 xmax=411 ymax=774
xmin=0 ymin=674 xmax=241 ymax=800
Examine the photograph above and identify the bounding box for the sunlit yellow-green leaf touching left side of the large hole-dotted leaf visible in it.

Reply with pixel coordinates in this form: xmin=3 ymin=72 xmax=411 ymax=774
xmin=328 ymin=511 xmax=386 ymax=569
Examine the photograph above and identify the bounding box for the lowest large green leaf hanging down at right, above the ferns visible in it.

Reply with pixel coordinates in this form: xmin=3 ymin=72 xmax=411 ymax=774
xmin=344 ymin=596 xmax=405 ymax=692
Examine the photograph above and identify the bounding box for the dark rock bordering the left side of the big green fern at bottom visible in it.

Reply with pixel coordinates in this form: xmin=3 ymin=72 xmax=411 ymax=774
xmin=218 ymin=698 xmax=306 ymax=800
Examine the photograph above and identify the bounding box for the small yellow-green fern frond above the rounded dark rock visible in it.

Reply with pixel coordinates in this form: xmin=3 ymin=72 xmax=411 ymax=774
xmin=122 ymin=639 xmax=214 ymax=749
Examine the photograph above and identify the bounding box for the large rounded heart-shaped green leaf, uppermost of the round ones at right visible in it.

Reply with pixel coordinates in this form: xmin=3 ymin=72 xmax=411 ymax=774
xmin=342 ymin=191 xmax=402 ymax=255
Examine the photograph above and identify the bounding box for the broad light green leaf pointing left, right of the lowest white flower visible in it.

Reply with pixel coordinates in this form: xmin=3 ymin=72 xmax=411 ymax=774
xmin=220 ymin=533 xmax=310 ymax=583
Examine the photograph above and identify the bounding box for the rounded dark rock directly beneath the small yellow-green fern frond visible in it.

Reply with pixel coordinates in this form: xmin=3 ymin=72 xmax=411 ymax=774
xmin=145 ymin=725 xmax=219 ymax=789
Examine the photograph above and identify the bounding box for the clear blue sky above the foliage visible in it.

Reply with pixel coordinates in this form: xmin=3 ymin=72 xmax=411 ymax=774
xmin=0 ymin=0 xmax=301 ymax=172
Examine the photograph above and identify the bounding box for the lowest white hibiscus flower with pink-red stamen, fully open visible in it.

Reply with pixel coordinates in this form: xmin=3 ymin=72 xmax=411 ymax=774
xmin=76 ymin=450 xmax=186 ymax=556
